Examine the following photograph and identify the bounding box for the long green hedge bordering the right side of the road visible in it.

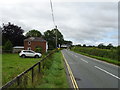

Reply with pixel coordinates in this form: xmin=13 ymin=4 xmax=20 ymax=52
xmin=71 ymin=46 xmax=120 ymax=61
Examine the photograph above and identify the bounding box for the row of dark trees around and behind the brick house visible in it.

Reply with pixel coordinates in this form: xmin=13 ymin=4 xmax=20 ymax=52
xmin=1 ymin=22 xmax=72 ymax=50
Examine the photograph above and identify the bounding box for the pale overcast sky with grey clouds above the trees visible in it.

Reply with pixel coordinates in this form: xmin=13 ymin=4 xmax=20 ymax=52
xmin=0 ymin=0 xmax=118 ymax=45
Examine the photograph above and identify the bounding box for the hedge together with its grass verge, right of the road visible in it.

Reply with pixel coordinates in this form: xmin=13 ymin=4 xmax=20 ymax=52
xmin=71 ymin=46 xmax=120 ymax=65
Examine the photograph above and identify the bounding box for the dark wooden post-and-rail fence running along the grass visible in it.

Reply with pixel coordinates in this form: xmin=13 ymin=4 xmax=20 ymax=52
xmin=0 ymin=50 xmax=55 ymax=90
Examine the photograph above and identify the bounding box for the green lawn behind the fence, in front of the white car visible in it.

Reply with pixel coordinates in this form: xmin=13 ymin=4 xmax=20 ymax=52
xmin=2 ymin=54 xmax=41 ymax=85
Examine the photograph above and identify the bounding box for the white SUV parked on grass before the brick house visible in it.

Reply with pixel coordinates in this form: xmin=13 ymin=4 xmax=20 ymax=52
xmin=19 ymin=50 xmax=42 ymax=58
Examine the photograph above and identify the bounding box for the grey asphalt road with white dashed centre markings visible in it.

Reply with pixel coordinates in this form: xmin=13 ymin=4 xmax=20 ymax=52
xmin=62 ymin=50 xmax=120 ymax=88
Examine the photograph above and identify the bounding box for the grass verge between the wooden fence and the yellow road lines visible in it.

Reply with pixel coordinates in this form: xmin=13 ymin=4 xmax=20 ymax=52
xmin=35 ymin=52 xmax=69 ymax=88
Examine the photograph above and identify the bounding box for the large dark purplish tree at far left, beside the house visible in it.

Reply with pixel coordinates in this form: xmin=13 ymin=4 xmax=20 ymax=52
xmin=2 ymin=22 xmax=24 ymax=46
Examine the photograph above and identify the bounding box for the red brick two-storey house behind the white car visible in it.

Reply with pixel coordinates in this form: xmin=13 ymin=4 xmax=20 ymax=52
xmin=24 ymin=37 xmax=48 ymax=53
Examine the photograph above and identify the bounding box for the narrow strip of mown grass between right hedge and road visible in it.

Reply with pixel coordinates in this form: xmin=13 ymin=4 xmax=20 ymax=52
xmin=72 ymin=50 xmax=120 ymax=66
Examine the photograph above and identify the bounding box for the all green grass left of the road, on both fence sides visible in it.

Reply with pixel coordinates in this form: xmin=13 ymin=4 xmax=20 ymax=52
xmin=2 ymin=51 xmax=69 ymax=88
